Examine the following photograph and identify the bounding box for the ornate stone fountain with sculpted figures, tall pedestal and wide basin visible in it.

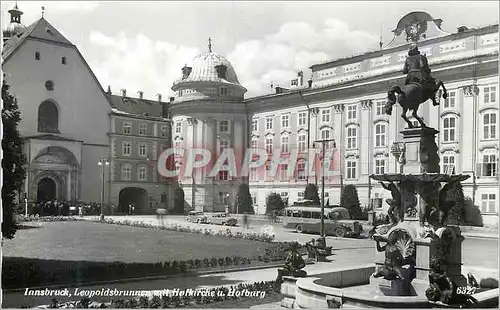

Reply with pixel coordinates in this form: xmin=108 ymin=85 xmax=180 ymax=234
xmin=281 ymin=43 xmax=499 ymax=308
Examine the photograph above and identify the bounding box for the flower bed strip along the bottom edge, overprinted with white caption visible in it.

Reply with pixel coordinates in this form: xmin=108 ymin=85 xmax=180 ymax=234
xmin=29 ymin=281 xmax=275 ymax=309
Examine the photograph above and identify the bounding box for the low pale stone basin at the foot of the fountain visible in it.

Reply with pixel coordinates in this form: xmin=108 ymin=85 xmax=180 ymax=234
xmin=281 ymin=264 xmax=499 ymax=309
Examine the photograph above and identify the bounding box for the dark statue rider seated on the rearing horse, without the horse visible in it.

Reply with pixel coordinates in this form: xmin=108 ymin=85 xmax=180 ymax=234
xmin=403 ymin=45 xmax=439 ymax=106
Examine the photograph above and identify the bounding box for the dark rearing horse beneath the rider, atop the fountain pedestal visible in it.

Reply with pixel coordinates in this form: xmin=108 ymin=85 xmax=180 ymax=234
xmin=385 ymin=81 xmax=448 ymax=128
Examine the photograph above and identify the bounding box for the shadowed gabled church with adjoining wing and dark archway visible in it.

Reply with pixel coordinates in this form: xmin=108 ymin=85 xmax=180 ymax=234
xmin=2 ymin=5 xmax=172 ymax=213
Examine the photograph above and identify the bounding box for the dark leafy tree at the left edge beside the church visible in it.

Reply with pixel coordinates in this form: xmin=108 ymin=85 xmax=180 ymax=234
xmin=2 ymin=79 xmax=26 ymax=239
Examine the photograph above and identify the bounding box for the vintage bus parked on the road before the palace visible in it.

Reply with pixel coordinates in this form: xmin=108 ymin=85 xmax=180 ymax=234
xmin=283 ymin=205 xmax=363 ymax=237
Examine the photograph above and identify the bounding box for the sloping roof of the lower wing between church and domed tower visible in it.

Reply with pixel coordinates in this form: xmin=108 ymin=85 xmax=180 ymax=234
xmin=108 ymin=95 xmax=165 ymax=118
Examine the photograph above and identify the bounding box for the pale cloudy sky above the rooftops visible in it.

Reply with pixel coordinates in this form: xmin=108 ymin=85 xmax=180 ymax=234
xmin=1 ymin=1 xmax=499 ymax=99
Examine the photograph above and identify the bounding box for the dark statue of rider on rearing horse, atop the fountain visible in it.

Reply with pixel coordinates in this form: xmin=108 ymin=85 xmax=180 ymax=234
xmin=385 ymin=45 xmax=448 ymax=128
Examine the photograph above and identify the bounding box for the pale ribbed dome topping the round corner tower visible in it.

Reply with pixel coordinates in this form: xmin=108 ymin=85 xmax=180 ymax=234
xmin=174 ymin=52 xmax=241 ymax=88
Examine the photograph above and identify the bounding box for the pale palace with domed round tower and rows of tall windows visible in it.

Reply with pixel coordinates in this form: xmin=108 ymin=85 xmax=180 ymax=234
xmin=170 ymin=12 xmax=499 ymax=225
